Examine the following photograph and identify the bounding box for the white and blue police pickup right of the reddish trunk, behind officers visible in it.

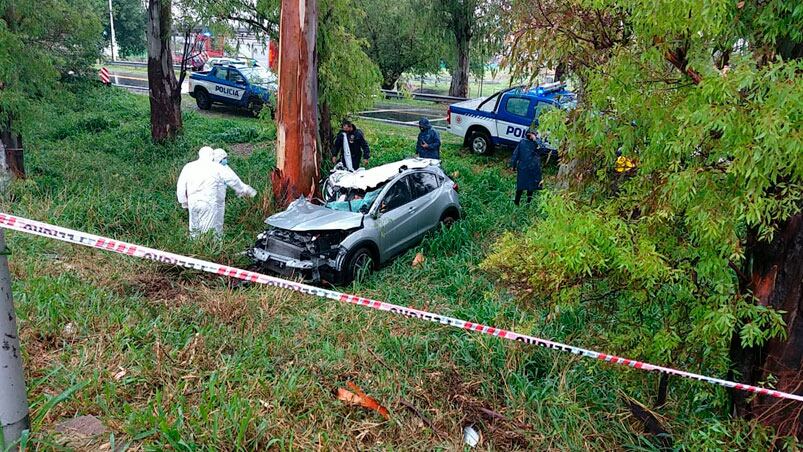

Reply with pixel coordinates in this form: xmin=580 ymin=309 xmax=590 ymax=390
xmin=446 ymin=83 xmax=577 ymax=154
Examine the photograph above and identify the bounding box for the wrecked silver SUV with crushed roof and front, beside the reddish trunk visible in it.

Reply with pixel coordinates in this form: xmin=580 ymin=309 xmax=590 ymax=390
xmin=247 ymin=158 xmax=462 ymax=284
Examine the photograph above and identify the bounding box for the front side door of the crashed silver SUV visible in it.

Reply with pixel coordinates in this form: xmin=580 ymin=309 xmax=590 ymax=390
xmin=376 ymin=176 xmax=417 ymax=257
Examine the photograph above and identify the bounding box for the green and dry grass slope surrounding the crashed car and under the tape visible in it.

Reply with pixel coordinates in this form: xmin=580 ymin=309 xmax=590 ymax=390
xmin=3 ymin=83 xmax=748 ymax=450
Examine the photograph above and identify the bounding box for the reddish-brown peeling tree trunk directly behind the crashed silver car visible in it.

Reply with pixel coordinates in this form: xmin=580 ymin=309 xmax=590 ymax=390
xmin=271 ymin=0 xmax=320 ymax=206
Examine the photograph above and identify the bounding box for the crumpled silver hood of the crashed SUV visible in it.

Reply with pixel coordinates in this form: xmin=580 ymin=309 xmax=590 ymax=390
xmin=265 ymin=197 xmax=363 ymax=232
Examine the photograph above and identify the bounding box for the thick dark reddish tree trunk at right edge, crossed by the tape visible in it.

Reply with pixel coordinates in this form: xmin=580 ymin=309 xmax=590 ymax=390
xmin=731 ymin=213 xmax=803 ymax=438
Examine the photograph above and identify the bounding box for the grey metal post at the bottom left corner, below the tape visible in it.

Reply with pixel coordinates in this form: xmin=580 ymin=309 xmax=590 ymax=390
xmin=0 ymin=229 xmax=29 ymax=449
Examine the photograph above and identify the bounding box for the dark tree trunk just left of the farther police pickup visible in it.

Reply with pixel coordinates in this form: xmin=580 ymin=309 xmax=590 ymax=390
xmin=147 ymin=0 xmax=182 ymax=143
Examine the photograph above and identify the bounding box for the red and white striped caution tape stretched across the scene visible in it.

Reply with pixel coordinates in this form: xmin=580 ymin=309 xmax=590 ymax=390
xmin=0 ymin=213 xmax=803 ymax=402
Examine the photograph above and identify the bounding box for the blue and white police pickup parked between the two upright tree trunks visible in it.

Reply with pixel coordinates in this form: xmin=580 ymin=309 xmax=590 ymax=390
xmin=189 ymin=64 xmax=277 ymax=115
